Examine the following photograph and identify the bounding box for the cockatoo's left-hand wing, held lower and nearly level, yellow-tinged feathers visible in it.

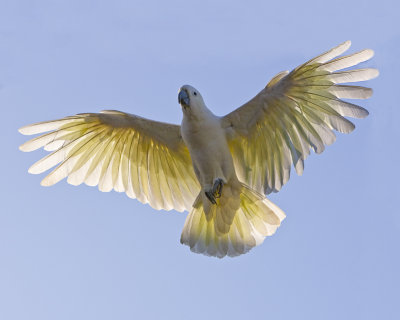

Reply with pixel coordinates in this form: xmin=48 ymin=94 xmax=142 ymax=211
xmin=19 ymin=111 xmax=200 ymax=211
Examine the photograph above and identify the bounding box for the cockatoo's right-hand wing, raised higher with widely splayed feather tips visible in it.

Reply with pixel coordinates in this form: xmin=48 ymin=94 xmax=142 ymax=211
xmin=222 ymin=41 xmax=378 ymax=193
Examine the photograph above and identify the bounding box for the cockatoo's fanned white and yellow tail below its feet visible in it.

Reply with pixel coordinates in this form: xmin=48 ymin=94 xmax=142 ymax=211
xmin=181 ymin=184 xmax=285 ymax=258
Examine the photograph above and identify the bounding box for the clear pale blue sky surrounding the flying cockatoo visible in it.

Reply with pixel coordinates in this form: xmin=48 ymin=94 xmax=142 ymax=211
xmin=0 ymin=0 xmax=400 ymax=320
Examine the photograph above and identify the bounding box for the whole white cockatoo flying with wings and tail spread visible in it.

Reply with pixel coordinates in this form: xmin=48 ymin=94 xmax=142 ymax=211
xmin=19 ymin=41 xmax=378 ymax=258
